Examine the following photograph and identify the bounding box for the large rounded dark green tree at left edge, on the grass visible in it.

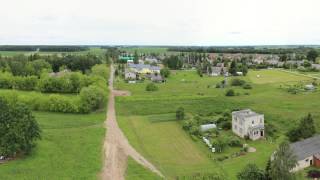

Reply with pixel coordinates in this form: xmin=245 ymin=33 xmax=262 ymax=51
xmin=0 ymin=98 xmax=40 ymax=157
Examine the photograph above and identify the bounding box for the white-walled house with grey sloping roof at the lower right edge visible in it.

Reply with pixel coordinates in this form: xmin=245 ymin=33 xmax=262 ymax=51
xmin=290 ymin=135 xmax=320 ymax=172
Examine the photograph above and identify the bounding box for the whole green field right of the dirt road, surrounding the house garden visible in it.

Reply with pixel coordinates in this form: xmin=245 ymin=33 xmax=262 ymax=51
xmin=116 ymin=70 xmax=320 ymax=179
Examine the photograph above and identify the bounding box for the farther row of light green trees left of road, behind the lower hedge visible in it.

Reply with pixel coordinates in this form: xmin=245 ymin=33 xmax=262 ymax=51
xmin=0 ymin=65 xmax=108 ymax=93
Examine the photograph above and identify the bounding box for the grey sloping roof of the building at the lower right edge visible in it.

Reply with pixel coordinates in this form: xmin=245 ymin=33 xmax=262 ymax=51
xmin=290 ymin=135 xmax=320 ymax=161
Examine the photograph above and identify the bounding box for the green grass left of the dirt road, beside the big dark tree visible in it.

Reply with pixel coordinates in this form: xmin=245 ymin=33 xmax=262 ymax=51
xmin=0 ymin=112 xmax=105 ymax=180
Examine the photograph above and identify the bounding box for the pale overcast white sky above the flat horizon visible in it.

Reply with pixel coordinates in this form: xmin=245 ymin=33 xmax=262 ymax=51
xmin=0 ymin=0 xmax=320 ymax=46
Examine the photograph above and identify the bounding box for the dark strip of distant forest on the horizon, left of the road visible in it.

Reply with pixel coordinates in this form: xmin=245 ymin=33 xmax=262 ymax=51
xmin=0 ymin=46 xmax=89 ymax=52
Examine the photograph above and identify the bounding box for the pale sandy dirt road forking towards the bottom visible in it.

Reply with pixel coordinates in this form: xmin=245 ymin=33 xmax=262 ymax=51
xmin=101 ymin=65 xmax=164 ymax=180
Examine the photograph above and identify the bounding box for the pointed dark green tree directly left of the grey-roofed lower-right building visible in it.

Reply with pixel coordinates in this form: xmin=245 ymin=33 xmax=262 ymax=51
xmin=270 ymin=142 xmax=297 ymax=180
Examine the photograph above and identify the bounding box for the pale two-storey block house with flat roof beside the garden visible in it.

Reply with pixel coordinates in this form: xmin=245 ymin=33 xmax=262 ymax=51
xmin=232 ymin=109 xmax=265 ymax=140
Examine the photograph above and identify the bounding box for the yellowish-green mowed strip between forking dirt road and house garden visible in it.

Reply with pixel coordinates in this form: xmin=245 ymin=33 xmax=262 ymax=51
xmin=117 ymin=116 xmax=219 ymax=178
